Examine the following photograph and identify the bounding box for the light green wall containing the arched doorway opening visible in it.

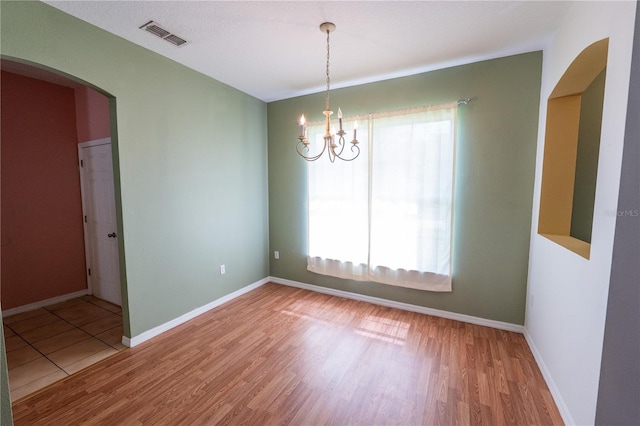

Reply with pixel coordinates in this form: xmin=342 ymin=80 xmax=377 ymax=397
xmin=0 ymin=1 xmax=269 ymax=337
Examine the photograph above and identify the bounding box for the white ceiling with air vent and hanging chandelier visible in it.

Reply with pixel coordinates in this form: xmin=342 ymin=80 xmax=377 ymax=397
xmin=37 ymin=0 xmax=571 ymax=102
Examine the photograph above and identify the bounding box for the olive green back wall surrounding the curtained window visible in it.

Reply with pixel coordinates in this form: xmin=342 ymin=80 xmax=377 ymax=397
xmin=268 ymin=52 xmax=542 ymax=324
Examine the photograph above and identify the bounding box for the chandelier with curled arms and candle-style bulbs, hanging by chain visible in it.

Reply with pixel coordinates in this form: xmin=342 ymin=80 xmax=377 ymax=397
xmin=296 ymin=22 xmax=360 ymax=163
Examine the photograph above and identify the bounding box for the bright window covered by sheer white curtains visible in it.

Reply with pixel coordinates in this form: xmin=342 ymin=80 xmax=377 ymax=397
xmin=307 ymin=103 xmax=456 ymax=291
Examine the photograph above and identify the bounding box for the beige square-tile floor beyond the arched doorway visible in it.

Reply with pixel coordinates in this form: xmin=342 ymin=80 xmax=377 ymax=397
xmin=3 ymin=296 xmax=125 ymax=401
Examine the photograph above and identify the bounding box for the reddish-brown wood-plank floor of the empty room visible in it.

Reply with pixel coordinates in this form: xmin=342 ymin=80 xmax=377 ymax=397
xmin=8 ymin=284 xmax=562 ymax=425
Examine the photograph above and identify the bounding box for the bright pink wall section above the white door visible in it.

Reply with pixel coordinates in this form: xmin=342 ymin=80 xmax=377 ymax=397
xmin=75 ymin=86 xmax=111 ymax=142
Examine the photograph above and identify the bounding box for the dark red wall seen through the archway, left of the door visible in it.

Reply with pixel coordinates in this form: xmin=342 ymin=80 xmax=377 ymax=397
xmin=0 ymin=71 xmax=87 ymax=310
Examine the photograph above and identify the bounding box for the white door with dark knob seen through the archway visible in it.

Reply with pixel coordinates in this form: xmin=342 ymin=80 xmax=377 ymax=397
xmin=78 ymin=138 xmax=122 ymax=306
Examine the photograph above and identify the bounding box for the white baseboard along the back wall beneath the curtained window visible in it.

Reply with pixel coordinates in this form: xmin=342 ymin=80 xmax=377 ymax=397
xmin=269 ymin=277 xmax=524 ymax=334
